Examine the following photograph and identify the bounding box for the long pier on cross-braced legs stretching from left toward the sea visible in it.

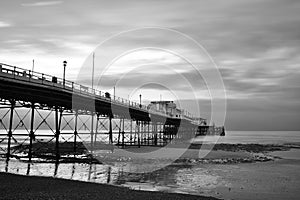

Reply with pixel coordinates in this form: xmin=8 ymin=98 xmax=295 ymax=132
xmin=0 ymin=63 xmax=220 ymax=160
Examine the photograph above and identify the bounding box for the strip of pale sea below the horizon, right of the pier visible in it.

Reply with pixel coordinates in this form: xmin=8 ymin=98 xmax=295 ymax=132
xmin=193 ymin=131 xmax=300 ymax=144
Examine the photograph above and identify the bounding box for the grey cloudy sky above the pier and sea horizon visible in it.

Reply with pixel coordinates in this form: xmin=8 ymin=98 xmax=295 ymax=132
xmin=0 ymin=0 xmax=300 ymax=130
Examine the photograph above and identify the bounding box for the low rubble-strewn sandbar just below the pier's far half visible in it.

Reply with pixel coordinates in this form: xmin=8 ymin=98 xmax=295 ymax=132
xmin=90 ymin=144 xmax=284 ymax=164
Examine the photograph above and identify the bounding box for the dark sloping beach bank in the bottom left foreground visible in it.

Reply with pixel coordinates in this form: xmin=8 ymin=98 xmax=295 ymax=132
xmin=0 ymin=173 xmax=216 ymax=200
